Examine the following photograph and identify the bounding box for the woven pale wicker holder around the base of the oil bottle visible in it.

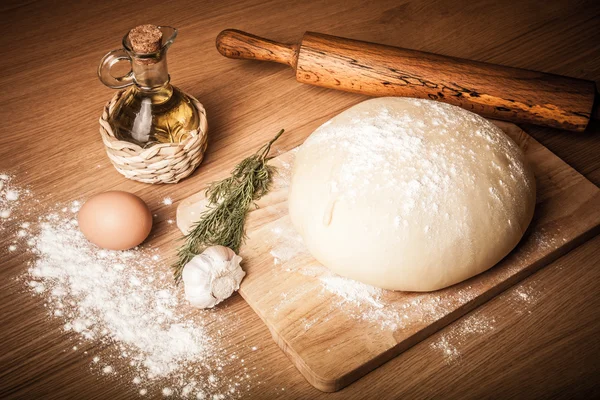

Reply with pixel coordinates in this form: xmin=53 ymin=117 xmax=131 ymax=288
xmin=100 ymin=91 xmax=208 ymax=183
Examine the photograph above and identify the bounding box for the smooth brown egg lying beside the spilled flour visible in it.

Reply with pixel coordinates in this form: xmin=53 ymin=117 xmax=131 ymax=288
xmin=77 ymin=191 xmax=152 ymax=250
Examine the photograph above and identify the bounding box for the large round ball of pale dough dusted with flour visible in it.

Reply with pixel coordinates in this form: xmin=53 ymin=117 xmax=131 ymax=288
xmin=289 ymin=97 xmax=535 ymax=291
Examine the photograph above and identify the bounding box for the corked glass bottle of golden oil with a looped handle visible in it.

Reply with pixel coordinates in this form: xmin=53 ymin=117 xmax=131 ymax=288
xmin=98 ymin=25 xmax=200 ymax=148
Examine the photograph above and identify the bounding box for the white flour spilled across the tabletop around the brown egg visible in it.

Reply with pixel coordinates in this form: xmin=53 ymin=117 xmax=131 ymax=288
xmin=0 ymin=175 xmax=257 ymax=399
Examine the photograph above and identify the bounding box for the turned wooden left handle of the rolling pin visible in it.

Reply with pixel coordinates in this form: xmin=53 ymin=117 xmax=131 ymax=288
xmin=216 ymin=29 xmax=298 ymax=69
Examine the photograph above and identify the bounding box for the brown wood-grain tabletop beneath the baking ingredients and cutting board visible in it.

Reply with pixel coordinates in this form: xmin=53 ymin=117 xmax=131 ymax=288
xmin=0 ymin=0 xmax=600 ymax=399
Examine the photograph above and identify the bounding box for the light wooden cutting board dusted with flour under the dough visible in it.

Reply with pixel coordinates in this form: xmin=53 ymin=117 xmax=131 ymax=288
xmin=177 ymin=121 xmax=600 ymax=392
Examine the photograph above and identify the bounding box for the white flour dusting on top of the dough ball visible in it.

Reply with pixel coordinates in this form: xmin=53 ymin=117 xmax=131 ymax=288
xmin=302 ymin=99 xmax=529 ymax=220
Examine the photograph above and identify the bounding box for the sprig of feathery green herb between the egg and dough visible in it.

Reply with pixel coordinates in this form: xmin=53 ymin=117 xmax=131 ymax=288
xmin=173 ymin=129 xmax=284 ymax=283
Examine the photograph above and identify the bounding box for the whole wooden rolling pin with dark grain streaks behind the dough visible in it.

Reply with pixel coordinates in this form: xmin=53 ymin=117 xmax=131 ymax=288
xmin=217 ymin=29 xmax=600 ymax=131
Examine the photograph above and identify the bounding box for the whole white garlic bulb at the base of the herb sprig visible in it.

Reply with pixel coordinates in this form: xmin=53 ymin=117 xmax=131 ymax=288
xmin=182 ymin=246 xmax=246 ymax=308
